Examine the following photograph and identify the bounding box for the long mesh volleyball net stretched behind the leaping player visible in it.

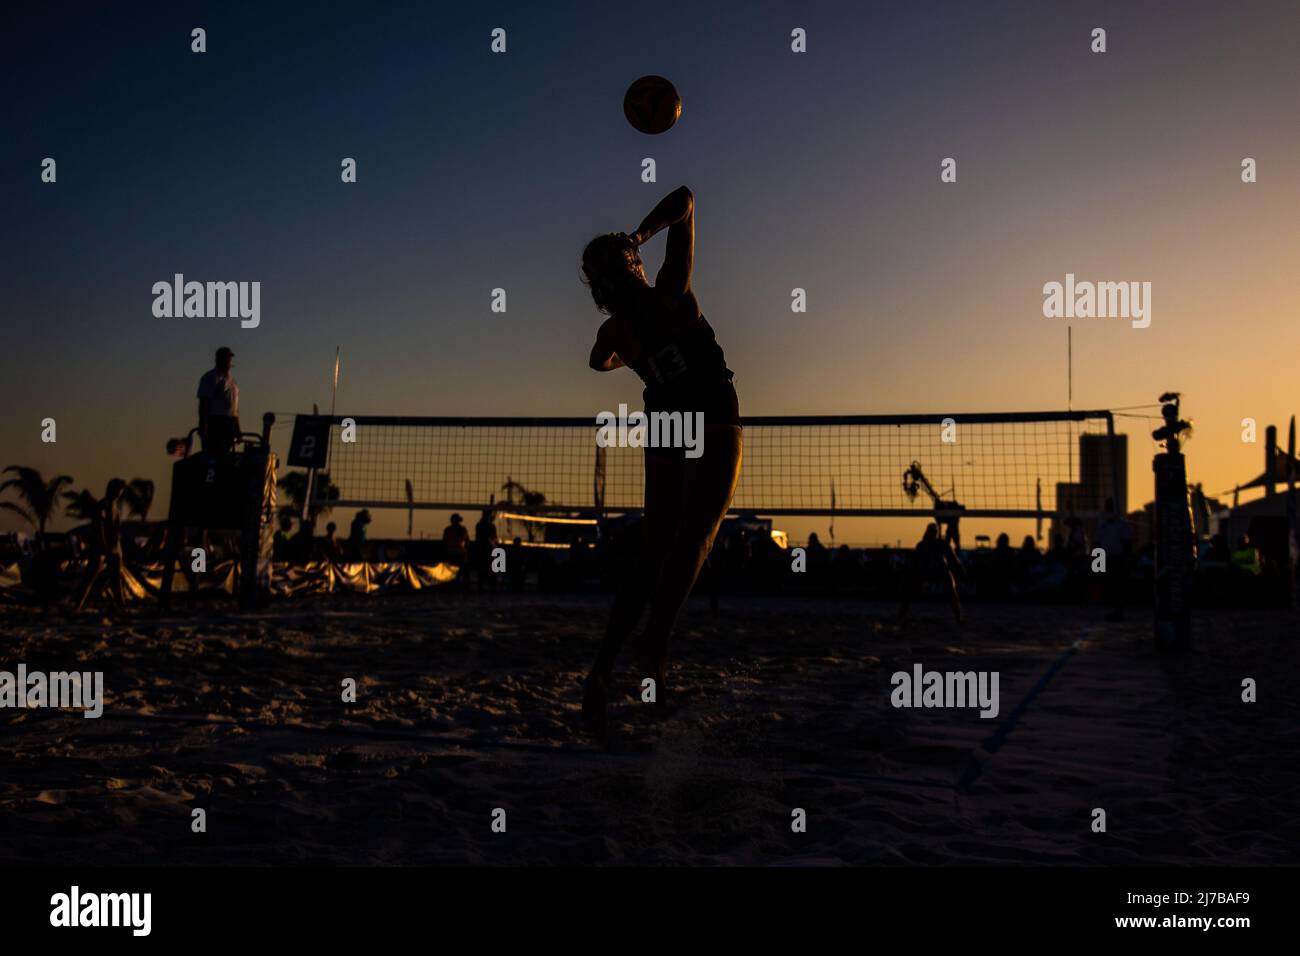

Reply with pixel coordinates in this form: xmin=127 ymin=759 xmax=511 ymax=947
xmin=289 ymin=411 xmax=1127 ymax=518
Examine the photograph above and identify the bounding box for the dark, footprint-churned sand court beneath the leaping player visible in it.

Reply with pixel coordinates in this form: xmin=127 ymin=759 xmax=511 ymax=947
xmin=0 ymin=592 xmax=1300 ymax=865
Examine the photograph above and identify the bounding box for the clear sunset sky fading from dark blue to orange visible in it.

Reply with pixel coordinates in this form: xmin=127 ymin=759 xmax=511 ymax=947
xmin=0 ymin=0 xmax=1300 ymax=541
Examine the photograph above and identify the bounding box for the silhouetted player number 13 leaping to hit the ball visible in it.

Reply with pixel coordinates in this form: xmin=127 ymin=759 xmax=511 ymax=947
xmin=582 ymin=186 xmax=744 ymax=739
